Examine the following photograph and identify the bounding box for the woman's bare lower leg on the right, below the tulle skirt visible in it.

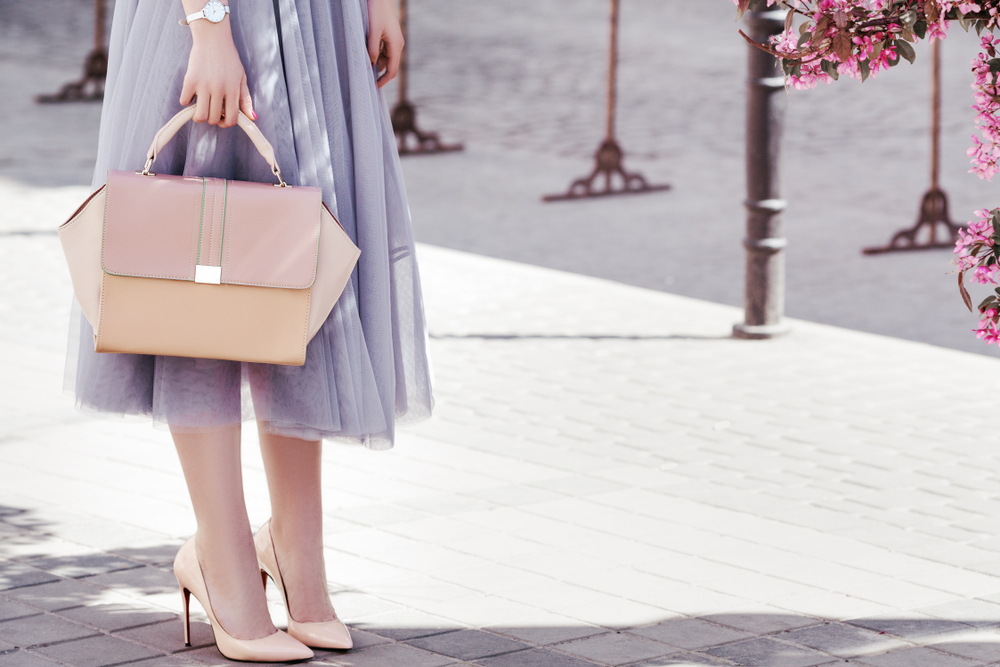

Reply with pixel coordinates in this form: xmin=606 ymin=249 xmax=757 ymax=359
xmin=257 ymin=422 xmax=335 ymax=623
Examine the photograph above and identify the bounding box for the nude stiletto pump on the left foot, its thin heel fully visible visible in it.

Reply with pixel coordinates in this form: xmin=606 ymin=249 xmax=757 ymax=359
xmin=174 ymin=537 xmax=313 ymax=662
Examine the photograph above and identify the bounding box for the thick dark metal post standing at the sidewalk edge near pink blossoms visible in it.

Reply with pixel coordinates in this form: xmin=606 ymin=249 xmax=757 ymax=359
xmin=733 ymin=9 xmax=789 ymax=339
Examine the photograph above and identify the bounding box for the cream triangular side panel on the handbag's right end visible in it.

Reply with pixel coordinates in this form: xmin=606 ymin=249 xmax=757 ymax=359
xmin=309 ymin=204 xmax=361 ymax=340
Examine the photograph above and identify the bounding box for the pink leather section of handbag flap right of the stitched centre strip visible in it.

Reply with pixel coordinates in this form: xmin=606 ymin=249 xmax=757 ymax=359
xmin=222 ymin=181 xmax=322 ymax=289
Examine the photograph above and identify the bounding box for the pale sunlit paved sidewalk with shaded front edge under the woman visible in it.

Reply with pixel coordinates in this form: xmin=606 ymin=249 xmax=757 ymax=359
xmin=0 ymin=206 xmax=1000 ymax=667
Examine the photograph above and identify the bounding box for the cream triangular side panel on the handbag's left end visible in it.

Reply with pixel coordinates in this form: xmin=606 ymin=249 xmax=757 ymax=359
xmin=59 ymin=186 xmax=107 ymax=329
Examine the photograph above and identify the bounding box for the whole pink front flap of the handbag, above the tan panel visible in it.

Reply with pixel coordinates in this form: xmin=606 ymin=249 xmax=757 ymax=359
xmin=101 ymin=171 xmax=322 ymax=289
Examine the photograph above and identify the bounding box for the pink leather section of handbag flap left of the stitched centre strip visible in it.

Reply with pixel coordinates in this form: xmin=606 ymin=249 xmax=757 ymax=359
xmin=101 ymin=170 xmax=202 ymax=280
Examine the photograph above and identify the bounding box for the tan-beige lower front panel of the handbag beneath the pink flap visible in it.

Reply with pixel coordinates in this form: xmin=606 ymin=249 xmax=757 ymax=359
xmin=95 ymin=274 xmax=310 ymax=366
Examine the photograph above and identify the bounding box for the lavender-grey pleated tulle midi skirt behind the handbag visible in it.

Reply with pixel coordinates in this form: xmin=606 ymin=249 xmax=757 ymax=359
xmin=66 ymin=0 xmax=433 ymax=449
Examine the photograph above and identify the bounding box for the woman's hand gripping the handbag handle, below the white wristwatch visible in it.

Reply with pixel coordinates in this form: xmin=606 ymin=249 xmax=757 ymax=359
xmin=180 ymin=0 xmax=257 ymax=127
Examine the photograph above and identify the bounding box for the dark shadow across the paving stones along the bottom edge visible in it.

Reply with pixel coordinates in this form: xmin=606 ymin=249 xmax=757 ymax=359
xmin=0 ymin=506 xmax=1000 ymax=667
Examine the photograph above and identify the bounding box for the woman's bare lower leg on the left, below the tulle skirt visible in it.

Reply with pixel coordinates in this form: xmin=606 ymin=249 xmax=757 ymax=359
xmin=172 ymin=426 xmax=275 ymax=639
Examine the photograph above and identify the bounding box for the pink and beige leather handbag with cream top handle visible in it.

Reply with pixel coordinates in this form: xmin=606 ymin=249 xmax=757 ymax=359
xmin=59 ymin=106 xmax=361 ymax=366
